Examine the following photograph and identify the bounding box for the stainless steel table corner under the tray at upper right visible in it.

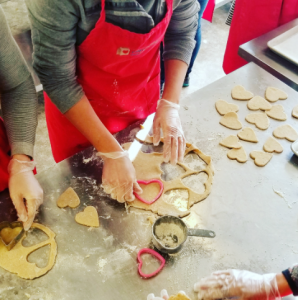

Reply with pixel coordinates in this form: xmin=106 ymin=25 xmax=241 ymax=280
xmin=238 ymin=19 xmax=298 ymax=91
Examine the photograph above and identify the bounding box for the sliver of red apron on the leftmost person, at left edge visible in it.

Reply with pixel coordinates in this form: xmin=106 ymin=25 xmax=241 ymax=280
xmin=0 ymin=118 xmax=10 ymax=192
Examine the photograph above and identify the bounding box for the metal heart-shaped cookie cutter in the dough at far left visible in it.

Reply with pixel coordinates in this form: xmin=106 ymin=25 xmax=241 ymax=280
xmin=0 ymin=222 xmax=25 ymax=251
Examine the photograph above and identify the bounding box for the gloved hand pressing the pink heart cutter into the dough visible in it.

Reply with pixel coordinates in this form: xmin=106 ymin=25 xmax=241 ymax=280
xmin=96 ymin=151 xmax=143 ymax=203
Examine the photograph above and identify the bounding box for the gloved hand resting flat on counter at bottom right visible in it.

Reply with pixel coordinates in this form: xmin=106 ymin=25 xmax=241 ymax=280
xmin=194 ymin=270 xmax=281 ymax=300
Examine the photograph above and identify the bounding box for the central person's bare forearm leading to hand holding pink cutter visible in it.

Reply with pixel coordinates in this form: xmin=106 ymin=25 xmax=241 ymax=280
xmin=64 ymin=96 xmax=123 ymax=153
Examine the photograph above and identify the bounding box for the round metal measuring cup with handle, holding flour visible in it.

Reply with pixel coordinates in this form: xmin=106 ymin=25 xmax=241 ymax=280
xmin=152 ymin=216 xmax=215 ymax=254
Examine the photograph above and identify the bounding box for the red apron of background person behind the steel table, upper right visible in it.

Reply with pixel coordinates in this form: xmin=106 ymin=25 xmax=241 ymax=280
xmin=223 ymin=0 xmax=298 ymax=74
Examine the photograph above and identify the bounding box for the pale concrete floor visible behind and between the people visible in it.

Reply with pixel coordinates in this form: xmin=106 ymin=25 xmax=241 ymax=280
xmin=1 ymin=0 xmax=230 ymax=172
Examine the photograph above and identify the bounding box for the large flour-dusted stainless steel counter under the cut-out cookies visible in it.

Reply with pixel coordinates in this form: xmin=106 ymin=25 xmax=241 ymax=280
xmin=0 ymin=63 xmax=298 ymax=300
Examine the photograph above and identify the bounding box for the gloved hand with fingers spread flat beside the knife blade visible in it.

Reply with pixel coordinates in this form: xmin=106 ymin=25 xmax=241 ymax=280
xmin=153 ymin=99 xmax=186 ymax=165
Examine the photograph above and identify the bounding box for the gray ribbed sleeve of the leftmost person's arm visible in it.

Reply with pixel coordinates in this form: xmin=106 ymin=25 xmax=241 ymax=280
xmin=0 ymin=7 xmax=37 ymax=157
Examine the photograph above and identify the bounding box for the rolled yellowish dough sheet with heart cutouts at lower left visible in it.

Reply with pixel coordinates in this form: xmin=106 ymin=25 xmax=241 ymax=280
xmin=0 ymin=223 xmax=57 ymax=279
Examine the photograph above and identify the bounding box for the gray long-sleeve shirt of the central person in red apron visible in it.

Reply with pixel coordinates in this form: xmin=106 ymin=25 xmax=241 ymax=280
xmin=26 ymin=0 xmax=199 ymax=113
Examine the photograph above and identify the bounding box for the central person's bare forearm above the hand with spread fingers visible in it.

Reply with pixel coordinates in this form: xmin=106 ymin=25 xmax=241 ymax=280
xmin=162 ymin=59 xmax=188 ymax=103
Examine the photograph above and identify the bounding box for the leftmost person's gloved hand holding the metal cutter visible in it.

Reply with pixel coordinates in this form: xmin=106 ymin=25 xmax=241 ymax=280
xmin=8 ymin=158 xmax=43 ymax=231
